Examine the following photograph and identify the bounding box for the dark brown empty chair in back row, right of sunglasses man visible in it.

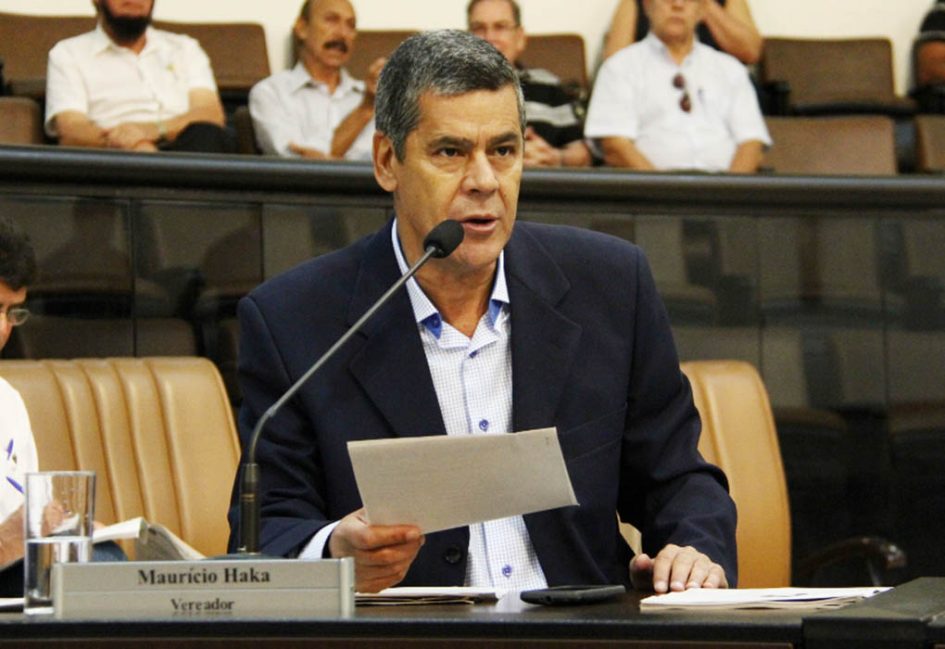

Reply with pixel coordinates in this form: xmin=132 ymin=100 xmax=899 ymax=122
xmin=760 ymin=38 xmax=913 ymax=115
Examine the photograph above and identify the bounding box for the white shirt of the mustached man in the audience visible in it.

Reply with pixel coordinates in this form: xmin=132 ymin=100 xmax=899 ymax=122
xmin=249 ymin=63 xmax=374 ymax=160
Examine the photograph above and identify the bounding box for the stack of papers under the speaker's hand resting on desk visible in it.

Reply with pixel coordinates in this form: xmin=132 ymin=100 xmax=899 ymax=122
xmin=640 ymin=586 xmax=889 ymax=611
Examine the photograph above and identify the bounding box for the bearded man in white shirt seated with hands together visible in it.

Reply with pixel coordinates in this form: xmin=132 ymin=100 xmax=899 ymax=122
xmin=46 ymin=0 xmax=235 ymax=153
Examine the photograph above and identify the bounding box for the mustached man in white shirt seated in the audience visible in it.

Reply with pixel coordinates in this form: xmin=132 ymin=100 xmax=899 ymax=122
xmin=249 ymin=0 xmax=384 ymax=160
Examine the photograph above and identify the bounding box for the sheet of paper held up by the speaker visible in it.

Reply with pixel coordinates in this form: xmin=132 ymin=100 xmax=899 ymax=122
xmin=348 ymin=428 xmax=578 ymax=534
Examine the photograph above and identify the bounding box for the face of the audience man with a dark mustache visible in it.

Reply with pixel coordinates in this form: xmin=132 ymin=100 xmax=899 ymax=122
xmin=295 ymin=0 xmax=357 ymax=70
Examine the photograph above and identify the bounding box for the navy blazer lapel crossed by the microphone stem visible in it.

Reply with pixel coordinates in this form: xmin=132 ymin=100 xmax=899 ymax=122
xmin=348 ymin=224 xmax=446 ymax=436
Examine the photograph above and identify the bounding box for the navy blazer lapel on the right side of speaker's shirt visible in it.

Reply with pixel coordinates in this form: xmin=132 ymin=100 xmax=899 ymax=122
xmin=506 ymin=224 xmax=581 ymax=431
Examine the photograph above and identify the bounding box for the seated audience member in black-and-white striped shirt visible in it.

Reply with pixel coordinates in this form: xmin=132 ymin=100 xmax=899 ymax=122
xmin=466 ymin=0 xmax=591 ymax=167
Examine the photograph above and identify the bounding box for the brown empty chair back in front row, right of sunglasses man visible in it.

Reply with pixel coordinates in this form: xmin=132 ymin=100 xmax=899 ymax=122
xmin=763 ymin=115 xmax=896 ymax=176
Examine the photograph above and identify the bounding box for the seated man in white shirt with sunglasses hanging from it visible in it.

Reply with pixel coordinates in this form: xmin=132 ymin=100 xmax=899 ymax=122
xmin=585 ymin=0 xmax=771 ymax=173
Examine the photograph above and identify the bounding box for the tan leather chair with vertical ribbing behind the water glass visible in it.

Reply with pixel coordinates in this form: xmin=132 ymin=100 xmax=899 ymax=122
xmin=0 ymin=357 xmax=239 ymax=556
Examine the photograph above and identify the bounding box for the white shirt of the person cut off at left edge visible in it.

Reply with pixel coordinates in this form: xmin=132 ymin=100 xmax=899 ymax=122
xmin=0 ymin=378 xmax=39 ymax=521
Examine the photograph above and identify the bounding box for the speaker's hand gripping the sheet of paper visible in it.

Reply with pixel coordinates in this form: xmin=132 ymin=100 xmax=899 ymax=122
xmin=328 ymin=509 xmax=424 ymax=593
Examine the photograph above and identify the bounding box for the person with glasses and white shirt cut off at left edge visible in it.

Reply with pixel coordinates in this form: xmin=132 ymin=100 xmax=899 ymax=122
xmin=0 ymin=216 xmax=38 ymax=595
